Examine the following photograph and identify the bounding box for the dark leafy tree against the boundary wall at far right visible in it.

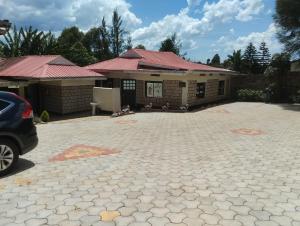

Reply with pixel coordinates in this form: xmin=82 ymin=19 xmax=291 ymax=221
xmin=264 ymin=53 xmax=291 ymax=101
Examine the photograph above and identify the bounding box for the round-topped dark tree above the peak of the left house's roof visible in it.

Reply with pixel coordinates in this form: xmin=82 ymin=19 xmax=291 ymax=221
xmin=57 ymin=26 xmax=84 ymax=57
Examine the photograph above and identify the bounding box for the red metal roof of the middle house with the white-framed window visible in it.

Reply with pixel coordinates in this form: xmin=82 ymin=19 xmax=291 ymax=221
xmin=86 ymin=49 xmax=229 ymax=72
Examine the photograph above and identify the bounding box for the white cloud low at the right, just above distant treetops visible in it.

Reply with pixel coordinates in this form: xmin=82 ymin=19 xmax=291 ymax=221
xmin=217 ymin=23 xmax=282 ymax=53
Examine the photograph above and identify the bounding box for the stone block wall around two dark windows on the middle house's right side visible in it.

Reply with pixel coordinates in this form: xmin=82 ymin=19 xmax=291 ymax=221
xmin=188 ymin=79 xmax=229 ymax=106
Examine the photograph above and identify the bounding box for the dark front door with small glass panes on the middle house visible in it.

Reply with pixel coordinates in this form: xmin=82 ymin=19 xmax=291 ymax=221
xmin=121 ymin=79 xmax=136 ymax=108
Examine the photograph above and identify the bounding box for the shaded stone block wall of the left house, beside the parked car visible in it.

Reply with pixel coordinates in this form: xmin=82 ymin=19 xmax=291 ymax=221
xmin=41 ymin=85 xmax=93 ymax=114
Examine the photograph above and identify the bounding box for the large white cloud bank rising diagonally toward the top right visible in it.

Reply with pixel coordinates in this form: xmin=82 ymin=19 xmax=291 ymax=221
xmin=132 ymin=0 xmax=264 ymax=50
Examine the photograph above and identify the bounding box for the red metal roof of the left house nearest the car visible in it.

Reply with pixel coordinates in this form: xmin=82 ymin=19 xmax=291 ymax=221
xmin=0 ymin=55 xmax=104 ymax=79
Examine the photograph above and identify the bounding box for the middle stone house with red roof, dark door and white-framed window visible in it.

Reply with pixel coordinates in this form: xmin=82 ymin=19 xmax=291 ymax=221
xmin=86 ymin=49 xmax=235 ymax=109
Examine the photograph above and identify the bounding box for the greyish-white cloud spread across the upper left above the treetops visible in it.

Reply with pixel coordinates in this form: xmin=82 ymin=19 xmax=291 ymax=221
xmin=0 ymin=0 xmax=142 ymax=31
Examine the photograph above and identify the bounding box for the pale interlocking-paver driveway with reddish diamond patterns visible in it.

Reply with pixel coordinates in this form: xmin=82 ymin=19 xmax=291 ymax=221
xmin=0 ymin=103 xmax=300 ymax=226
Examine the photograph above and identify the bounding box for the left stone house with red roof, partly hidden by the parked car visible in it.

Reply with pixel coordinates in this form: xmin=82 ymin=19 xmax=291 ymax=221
xmin=0 ymin=55 xmax=105 ymax=114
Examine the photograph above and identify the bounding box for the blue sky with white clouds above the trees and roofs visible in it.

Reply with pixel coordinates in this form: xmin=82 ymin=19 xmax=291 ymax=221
xmin=0 ymin=0 xmax=282 ymax=62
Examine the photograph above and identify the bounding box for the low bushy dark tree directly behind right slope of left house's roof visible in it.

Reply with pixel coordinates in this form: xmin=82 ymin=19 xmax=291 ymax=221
xmin=66 ymin=42 xmax=96 ymax=66
